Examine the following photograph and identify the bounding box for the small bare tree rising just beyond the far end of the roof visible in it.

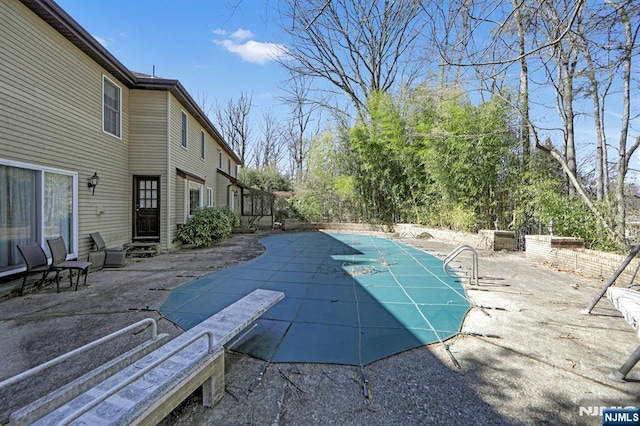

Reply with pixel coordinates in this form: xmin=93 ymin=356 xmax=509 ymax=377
xmin=215 ymin=92 xmax=253 ymax=164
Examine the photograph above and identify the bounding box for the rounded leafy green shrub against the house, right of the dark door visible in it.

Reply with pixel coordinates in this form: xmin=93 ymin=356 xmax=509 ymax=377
xmin=176 ymin=208 xmax=235 ymax=247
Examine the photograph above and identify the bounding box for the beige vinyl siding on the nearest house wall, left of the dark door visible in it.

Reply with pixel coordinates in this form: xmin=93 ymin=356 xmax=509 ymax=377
xmin=0 ymin=0 xmax=131 ymax=258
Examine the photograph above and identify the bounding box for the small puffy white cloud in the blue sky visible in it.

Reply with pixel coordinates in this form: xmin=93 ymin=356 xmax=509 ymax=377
xmin=213 ymin=28 xmax=288 ymax=64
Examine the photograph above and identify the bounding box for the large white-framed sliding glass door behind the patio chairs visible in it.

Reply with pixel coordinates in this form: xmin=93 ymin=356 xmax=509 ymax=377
xmin=0 ymin=162 xmax=78 ymax=276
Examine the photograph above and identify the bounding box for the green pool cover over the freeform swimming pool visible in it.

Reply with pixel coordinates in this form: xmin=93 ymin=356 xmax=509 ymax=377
xmin=160 ymin=232 xmax=470 ymax=365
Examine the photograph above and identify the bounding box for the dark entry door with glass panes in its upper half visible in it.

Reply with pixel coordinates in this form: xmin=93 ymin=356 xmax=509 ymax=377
xmin=133 ymin=176 xmax=160 ymax=239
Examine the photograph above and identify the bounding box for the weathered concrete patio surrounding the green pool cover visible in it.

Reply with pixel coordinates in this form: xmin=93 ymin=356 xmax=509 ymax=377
xmin=0 ymin=233 xmax=640 ymax=425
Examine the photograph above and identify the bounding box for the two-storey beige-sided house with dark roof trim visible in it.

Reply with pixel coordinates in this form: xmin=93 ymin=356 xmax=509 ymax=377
xmin=0 ymin=0 xmax=243 ymax=277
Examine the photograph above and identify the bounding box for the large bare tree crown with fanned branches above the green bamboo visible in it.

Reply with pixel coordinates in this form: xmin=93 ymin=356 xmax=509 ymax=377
xmin=280 ymin=0 xmax=424 ymax=117
